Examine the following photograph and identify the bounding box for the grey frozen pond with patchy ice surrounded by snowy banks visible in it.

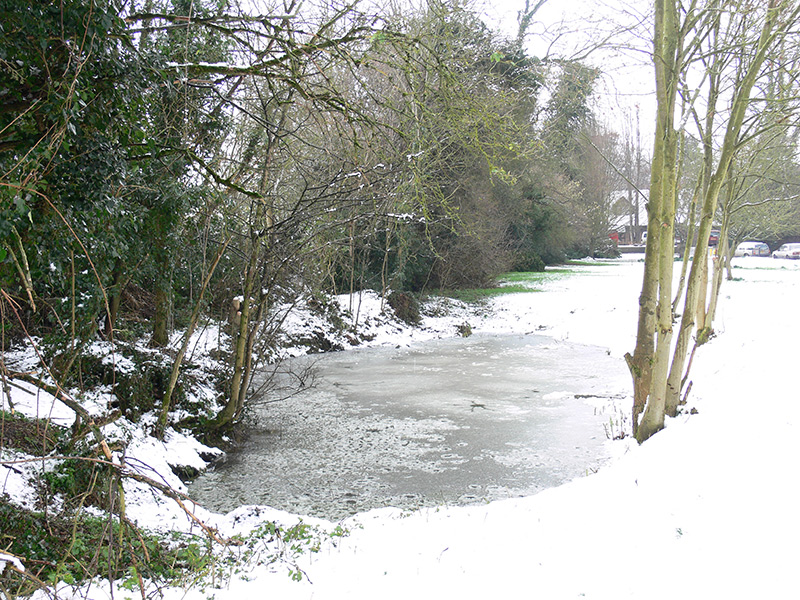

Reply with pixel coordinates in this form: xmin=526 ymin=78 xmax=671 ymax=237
xmin=189 ymin=335 xmax=630 ymax=520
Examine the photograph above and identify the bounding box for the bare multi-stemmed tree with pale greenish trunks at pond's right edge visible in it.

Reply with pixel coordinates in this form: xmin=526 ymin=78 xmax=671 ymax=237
xmin=627 ymin=0 xmax=800 ymax=442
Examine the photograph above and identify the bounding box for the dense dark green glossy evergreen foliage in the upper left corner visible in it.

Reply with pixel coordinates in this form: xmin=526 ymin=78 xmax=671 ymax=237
xmin=0 ymin=0 xmax=155 ymax=340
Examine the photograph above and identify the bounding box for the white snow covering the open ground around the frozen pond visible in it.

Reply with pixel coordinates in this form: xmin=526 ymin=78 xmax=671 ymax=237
xmin=6 ymin=258 xmax=800 ymax=600
